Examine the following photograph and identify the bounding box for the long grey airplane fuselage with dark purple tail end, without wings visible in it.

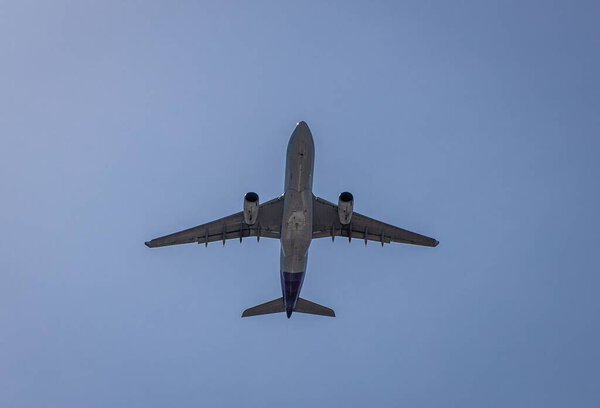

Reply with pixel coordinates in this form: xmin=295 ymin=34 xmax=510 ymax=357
xmin=280 ymin=122 xmax=315 ymax=318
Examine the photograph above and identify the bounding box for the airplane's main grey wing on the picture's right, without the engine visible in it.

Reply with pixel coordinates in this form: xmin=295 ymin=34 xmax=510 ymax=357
xmin=313 ymin=197 xmax=438 ymax=247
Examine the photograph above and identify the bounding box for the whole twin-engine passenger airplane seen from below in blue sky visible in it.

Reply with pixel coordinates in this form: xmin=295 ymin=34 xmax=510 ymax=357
xmin=145 ymin=122 xmax=439 ymax=319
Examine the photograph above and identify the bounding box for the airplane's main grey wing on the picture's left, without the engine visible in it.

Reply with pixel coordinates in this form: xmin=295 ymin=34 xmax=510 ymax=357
xmin=146 ymin=196 xmax=283 ymax=248
